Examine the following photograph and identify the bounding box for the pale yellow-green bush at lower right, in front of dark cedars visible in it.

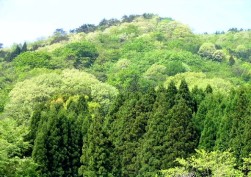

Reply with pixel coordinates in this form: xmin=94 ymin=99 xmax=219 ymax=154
xmin=162 ymin=150 xmax=243 ymax=177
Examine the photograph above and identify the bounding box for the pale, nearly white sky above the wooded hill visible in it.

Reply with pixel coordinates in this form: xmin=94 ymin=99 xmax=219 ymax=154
xmin=0 ymin=0 xmax=251 ymax=46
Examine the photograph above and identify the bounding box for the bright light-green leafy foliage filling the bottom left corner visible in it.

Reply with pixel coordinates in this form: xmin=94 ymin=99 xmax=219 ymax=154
xmin=0 ymin=118 xmax=38 ymax=177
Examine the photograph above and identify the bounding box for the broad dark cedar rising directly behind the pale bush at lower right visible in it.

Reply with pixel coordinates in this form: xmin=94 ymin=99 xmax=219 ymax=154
xmin=164 ymin=98 xmax=198 ymax=169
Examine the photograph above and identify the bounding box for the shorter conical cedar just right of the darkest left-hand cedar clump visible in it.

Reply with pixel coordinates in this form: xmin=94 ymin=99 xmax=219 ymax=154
xmin=79 ymin=111 xmax=112 ymax=177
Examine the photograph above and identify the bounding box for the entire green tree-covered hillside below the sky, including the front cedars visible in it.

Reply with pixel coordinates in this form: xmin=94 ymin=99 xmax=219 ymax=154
xmin=0 ymin=14 xmax=251 ymax=177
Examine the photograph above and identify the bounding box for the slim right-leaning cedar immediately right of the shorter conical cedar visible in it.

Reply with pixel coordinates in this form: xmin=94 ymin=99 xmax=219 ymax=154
xmin=112 ymin=92 xmax=139 ymax=176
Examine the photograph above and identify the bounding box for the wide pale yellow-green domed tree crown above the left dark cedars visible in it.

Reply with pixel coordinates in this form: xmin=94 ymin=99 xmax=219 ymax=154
xmin=5 ymin=70 xmax=117 ymax=121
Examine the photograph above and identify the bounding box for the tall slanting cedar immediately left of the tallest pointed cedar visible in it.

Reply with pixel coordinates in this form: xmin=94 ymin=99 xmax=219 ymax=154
xmin=138 ymin=82 xmax=177 ymax=176
